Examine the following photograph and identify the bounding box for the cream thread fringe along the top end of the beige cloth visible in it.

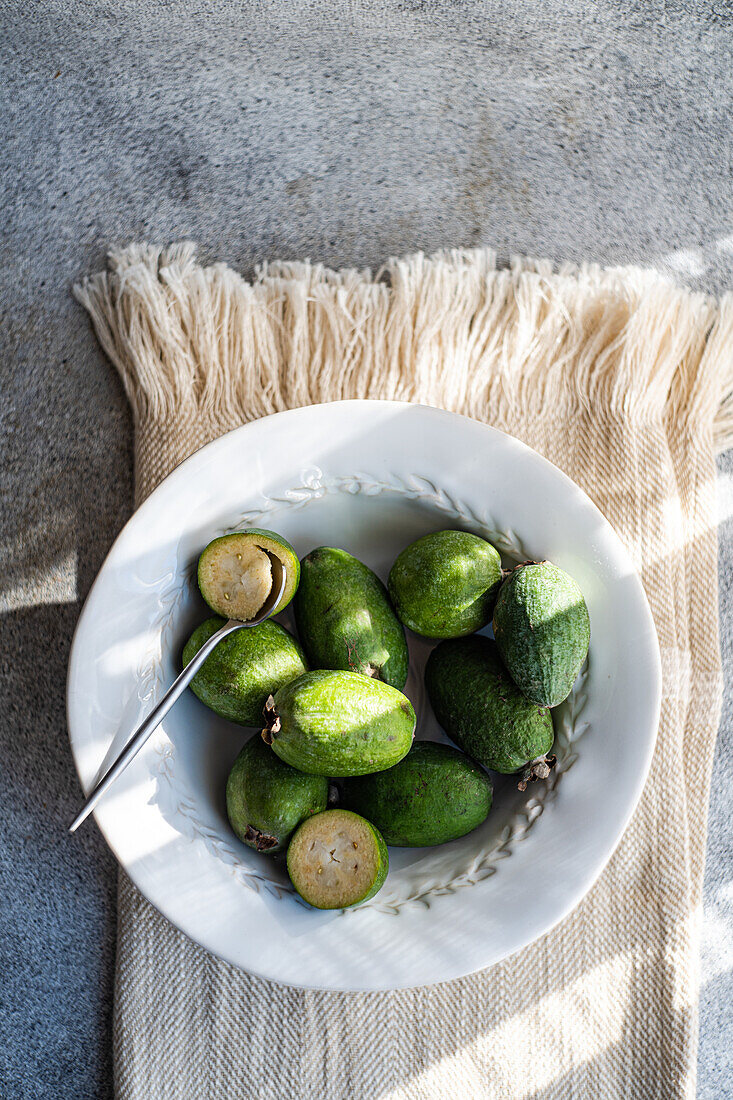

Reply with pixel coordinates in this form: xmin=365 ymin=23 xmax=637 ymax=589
xmin=74 ymin=242 xmax=733 ymax=450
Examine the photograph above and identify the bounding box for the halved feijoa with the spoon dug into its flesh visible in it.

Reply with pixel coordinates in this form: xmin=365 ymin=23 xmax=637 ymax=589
xmin=198 ymin=527 xmax=300 ymax=623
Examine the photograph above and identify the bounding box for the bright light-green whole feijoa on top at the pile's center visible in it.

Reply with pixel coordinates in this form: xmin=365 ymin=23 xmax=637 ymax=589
xmin=262 ymin=670 xmax=415 ymax=777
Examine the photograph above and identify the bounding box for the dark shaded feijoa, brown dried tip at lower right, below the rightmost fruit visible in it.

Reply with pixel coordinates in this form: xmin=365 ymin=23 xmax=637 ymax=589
xmin=425 ymin=635 xmax=555 ymax=774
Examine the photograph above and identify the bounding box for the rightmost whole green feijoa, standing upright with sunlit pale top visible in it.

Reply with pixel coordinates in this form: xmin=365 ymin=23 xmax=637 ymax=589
xmin=494 ymin=561 xmax=590 ymax=706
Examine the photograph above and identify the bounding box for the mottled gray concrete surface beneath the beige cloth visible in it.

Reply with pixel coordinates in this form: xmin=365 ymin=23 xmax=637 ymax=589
xmin=0 ymin=0 xmax=733 ymax=1100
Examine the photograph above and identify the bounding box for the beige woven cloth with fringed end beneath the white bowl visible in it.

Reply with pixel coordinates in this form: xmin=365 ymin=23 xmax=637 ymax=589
xmin=76 ymin=244 xmax=733 ymax=1100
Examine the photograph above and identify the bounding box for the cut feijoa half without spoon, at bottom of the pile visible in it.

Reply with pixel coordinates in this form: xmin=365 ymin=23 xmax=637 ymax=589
xmin=287 ymin=810 xmax=390 ymax=909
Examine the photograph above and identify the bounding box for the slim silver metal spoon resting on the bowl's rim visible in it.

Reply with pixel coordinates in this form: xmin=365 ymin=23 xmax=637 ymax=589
xmin=69 ymin=550 xmax=286 ymax=833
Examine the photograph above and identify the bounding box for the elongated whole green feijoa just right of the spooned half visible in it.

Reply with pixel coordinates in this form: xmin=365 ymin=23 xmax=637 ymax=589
xmin=294 ymin=547 xmax=408 ymax=689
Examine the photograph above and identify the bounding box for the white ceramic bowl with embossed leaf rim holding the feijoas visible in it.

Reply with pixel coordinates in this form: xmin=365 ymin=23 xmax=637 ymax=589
xmin=68 ymin=402 xmax=660 ymax=990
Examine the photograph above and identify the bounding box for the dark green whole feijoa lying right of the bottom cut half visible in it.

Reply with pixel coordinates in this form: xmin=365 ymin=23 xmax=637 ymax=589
xmin=342 ymin=741 xmax=492 ymax=848
